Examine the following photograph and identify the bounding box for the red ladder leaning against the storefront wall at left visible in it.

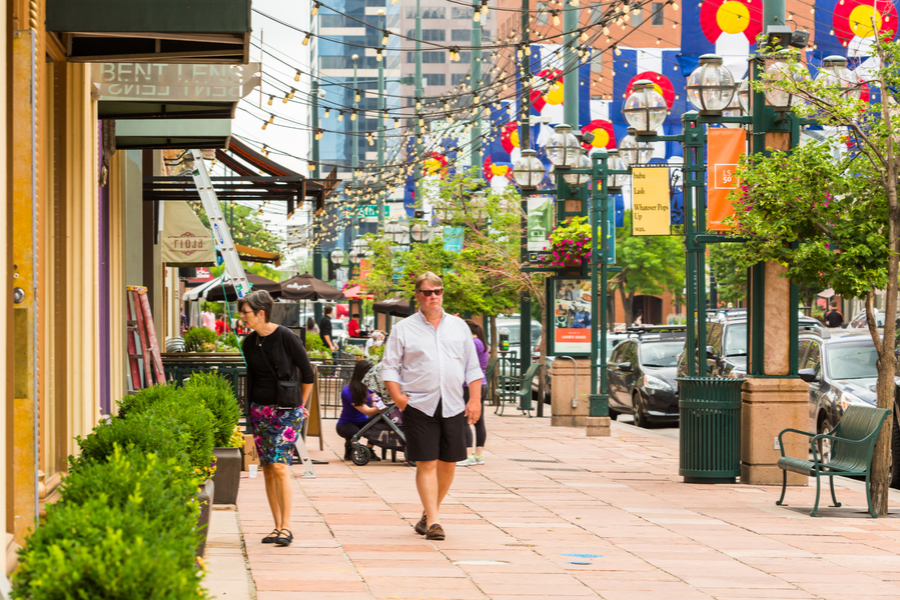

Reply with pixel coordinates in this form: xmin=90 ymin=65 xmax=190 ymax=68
xmin=125 ymin=285 xmax=166 ymax=390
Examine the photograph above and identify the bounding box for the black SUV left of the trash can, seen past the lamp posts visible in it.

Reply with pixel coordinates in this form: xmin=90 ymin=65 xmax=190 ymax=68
xmin=607 ymin=325 xmax=685 ymax=427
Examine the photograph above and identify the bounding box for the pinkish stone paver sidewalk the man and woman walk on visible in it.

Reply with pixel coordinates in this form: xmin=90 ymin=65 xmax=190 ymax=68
xmin=221 ymin=412 xmax=900 ymax=600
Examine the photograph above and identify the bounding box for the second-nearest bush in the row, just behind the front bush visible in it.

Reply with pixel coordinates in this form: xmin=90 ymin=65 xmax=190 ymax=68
xmin=69 ymin=413 xmax=191 ymax=471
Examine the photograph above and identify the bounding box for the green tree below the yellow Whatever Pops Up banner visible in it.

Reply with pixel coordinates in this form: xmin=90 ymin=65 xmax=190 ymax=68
xmin=611 ymin=210 xmax=684 ymax=324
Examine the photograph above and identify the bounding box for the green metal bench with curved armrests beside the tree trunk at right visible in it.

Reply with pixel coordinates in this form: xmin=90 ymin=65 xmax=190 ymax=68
xmin=775 ymin=406 xmax=890 ymax=519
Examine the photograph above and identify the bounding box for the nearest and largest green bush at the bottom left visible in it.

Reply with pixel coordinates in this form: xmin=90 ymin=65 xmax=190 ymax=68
xmin=12 ymin=448 xmax=207 ymax=600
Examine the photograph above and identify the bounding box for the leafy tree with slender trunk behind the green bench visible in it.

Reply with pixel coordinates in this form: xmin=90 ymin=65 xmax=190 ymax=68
xmin=732 ymin=36 xmax=900 ymax=514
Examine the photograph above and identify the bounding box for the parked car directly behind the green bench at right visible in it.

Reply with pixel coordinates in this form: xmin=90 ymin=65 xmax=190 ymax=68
xmin=799 ymin=331 xmax=900 ymax=488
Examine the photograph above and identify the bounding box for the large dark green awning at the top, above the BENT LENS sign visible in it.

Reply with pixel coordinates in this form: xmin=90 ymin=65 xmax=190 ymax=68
xmin=46 ymin=0 xmax=251 ymax=65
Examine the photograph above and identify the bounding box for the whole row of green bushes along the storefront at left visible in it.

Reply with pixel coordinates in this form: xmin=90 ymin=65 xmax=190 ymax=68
xmin=13 ymin=374 xmax=240 ymax=600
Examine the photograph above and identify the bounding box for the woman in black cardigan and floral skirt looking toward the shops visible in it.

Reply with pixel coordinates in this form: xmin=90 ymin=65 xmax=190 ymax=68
xmin=238 ymin=290 xmax=315 ymax=546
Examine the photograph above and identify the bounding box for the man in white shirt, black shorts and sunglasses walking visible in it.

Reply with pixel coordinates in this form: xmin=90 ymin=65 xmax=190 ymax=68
xmin=381 ymin=271 xmax=484 ymax=540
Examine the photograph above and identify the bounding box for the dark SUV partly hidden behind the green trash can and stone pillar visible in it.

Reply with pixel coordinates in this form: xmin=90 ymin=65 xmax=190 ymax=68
xmin=678 ymin=314 xmax=826 ymax=377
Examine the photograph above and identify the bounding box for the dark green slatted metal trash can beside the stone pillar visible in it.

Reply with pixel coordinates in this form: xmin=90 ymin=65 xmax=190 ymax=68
xmin=678 ymin=377 xmax=746 ymax=483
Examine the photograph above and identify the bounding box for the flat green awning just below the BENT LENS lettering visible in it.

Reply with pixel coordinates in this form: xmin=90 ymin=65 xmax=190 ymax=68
xmin=116 ymin=119 xmax=231 ymax=150
